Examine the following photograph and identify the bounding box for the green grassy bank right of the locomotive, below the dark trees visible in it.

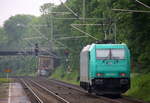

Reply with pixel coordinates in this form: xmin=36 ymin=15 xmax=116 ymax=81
xmin=125 ymin=73 xmax=150 ymax=102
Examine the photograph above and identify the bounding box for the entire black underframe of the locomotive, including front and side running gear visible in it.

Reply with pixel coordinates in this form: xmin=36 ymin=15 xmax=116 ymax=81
xmin=80 ymin=78 xmax=130 ymax=94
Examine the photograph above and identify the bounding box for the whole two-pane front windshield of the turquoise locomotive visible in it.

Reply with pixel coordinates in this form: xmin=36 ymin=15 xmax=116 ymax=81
xmin=96 ymin=49 xmax=125 ymax=60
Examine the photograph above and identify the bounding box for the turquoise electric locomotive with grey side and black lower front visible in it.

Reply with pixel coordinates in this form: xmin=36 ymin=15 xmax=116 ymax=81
xmin=80 ymin=44 xmax=130 ymax=95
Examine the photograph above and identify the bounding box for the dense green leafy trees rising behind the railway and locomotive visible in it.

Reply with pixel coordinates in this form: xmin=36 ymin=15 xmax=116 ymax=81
xmin=0 ymin=0 xmax=150 ymax=76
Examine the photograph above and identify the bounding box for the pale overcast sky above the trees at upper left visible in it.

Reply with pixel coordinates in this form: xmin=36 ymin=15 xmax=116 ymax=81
xmin=0 ymin=0 xmax=65 ymax=26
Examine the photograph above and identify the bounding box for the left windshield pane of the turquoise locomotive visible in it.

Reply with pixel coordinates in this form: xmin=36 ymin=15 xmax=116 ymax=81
xmin=96 ymin=49 xmax=110 ymax=59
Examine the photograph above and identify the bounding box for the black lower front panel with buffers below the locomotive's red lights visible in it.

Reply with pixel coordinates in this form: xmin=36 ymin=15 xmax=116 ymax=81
xmin=92 ymin=78 xmax=130 ymax=93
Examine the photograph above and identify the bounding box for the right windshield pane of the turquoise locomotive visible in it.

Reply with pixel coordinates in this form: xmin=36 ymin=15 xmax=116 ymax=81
xmin=111 ymin=49 xmax=125 ymax=59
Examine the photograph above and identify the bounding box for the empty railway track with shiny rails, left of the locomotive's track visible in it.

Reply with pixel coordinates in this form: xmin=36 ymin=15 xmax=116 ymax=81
xmin=21 ymin=79 xmax=70 ymax=103
